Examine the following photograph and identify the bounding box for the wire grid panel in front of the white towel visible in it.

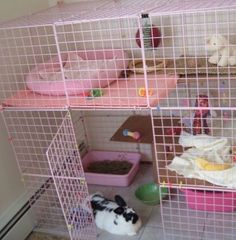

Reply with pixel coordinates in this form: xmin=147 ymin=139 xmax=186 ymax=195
xmin=153 ymin=108 xmax=236 ymax=189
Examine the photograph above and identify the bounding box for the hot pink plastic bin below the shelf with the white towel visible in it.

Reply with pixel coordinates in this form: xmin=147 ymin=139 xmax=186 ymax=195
xmin=181 ymin=189 xmax=236 ymax=212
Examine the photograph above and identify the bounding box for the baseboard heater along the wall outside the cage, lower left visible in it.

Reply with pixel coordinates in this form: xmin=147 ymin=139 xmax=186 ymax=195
xmin=0 ymin=177 xmax=53 ymax=240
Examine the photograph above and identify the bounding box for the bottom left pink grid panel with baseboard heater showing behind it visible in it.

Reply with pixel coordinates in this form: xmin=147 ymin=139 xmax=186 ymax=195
xmin=22 ymin=175 xmax=69 ymax=237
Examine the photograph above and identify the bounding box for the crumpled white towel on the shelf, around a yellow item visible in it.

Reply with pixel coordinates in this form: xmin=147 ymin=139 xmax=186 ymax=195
xmin=167 ymin=132 xmax=236 ymax=188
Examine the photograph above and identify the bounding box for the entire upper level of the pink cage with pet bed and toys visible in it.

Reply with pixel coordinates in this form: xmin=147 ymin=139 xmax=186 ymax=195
xmin=0 ymin=0 xmax=236 ymax=108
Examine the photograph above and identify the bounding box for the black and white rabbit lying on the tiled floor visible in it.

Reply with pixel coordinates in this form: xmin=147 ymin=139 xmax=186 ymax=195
xmin=91 ymin=193 xmax=142 ymax=236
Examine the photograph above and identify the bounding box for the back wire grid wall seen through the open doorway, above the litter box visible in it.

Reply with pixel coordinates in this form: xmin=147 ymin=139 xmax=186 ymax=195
xmin=72 ymin=110 xmax=153 ymax=162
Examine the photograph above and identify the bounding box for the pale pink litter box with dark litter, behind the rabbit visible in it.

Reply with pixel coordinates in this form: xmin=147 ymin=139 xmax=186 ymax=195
xmin=82 ymin=151 xmax=141 ymax=187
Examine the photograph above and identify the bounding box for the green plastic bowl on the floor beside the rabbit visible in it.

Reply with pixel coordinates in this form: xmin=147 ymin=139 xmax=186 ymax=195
xmin=135 ymin=183 xmax=168 ymax=205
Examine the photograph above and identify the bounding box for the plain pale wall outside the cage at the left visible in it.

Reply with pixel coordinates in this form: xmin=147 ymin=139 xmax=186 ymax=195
xmin=0 ymin=0 xmax=49 ymax=234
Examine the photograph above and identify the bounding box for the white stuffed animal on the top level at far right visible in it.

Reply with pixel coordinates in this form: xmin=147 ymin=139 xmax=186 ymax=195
xmin=207 ymin=34 xmax=236 ymax=67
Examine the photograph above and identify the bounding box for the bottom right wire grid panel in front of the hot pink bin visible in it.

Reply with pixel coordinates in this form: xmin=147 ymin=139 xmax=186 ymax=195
xmin=160 ymin=188 xmax=236 ymax=240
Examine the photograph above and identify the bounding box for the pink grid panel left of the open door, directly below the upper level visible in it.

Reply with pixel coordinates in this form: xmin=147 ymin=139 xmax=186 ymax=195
xmin=3 ymin=110 xmax=67 ymax=177
